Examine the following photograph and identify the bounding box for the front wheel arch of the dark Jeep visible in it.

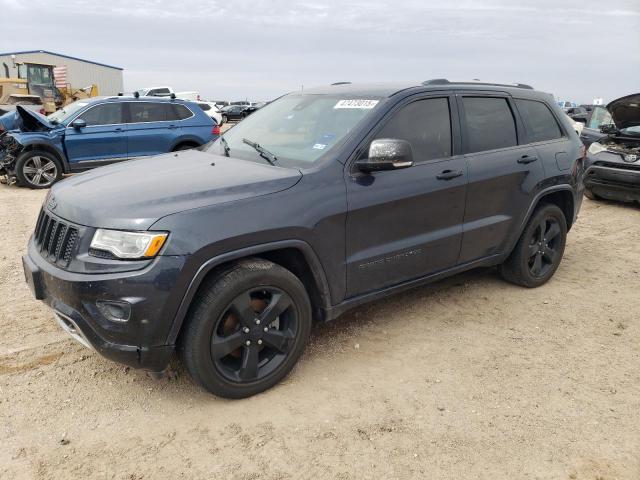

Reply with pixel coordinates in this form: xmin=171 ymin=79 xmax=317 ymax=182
xmin=167 ymin=240 xmax=331 ymax=345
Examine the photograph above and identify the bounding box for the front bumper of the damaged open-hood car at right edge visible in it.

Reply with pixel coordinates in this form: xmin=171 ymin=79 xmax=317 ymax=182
xmin=584 ymin=163 xmax=640 ymax=202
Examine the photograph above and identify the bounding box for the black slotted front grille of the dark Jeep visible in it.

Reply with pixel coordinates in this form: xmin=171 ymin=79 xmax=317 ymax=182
xmin=34 ymin=210 xmax=78 ymax=267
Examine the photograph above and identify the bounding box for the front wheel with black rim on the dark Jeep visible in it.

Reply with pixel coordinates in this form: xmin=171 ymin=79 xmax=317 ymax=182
xmin=178 ymin=259 xmax=311 ymax=398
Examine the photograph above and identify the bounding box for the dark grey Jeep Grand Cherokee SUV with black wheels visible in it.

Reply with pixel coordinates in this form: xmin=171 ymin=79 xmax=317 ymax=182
xmin=23 ymin=79 xmax=584 ymax=398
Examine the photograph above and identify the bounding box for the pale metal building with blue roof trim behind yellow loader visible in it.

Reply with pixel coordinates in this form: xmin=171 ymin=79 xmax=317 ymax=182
xmin=0 ymin=50 xmax=124 ymax=95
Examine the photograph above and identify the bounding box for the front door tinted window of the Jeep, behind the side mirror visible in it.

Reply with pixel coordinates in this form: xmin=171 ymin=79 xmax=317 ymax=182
xmin=376 ymin=98 xmax=451 ymax=162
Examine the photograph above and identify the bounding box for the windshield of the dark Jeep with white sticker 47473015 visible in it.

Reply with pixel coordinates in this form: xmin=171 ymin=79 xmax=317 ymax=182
xmin=206 ymin=94 xmax=381 ymax=167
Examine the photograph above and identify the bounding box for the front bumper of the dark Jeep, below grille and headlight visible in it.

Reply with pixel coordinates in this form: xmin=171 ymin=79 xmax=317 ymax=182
xmin=23 ymin=240 xmax=186 ymax=372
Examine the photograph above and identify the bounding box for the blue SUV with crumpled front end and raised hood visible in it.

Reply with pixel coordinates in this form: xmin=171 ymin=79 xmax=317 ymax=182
xmin=0 ymin=96 xmax=220 ymax=188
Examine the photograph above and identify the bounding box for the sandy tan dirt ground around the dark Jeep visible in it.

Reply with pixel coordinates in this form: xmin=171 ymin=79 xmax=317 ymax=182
xmin=0 ymin=185 xmax=640 ymax=480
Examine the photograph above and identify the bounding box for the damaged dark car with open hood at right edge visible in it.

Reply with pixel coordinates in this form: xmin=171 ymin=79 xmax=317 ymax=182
xmin=584 ymin=93 xmax=640 ymax=203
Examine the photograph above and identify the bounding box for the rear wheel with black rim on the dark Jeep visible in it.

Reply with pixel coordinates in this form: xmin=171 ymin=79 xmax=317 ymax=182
xmin=498 ymin=204 xmax=567 ymax=288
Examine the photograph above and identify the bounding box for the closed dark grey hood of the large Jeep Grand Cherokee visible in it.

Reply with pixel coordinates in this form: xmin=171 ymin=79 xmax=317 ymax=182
xmin=47 ymin=150 xmax=302 ymax=230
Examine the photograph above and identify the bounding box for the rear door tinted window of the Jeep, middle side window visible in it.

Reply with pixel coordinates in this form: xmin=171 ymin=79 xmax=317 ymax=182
xmin=463 ymin=97 xmax=518 ymax=152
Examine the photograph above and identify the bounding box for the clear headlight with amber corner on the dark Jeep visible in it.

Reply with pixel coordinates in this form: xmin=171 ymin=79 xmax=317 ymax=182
xmin=91 ymin=228 xmax=168 ymax=259
